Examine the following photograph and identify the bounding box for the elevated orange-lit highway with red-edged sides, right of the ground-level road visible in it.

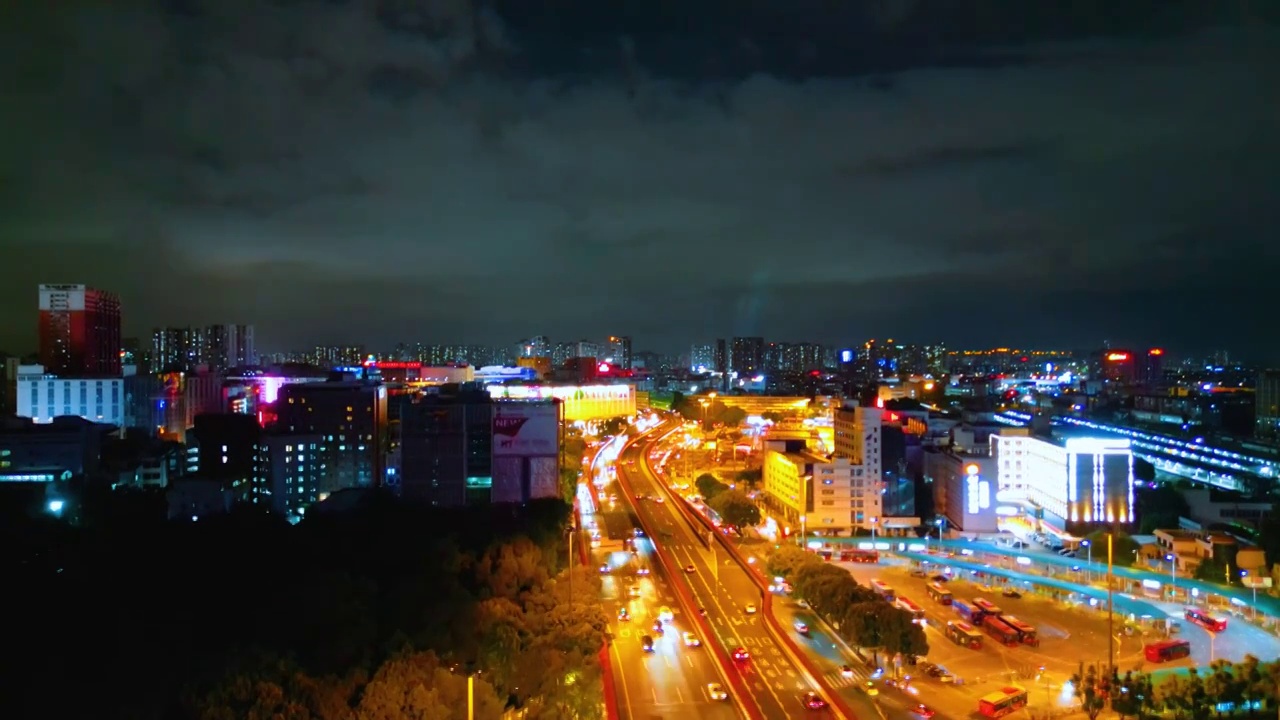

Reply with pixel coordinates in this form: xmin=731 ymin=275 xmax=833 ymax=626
xmin=618 ymin=430 xmax=835 ymax=719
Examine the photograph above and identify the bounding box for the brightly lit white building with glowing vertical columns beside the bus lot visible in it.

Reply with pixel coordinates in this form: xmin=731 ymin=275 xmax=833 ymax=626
xmin=991 ymin=428 xmax=1134 ymax=533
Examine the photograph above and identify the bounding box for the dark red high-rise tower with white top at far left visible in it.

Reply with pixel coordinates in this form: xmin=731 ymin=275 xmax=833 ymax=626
xmin=40 ymin=284 xmax=120 ymax=377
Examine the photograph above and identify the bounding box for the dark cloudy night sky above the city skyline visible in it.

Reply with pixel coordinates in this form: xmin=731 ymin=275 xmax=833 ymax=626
xmin=0 ymin=0 xmax=1280 ymax=359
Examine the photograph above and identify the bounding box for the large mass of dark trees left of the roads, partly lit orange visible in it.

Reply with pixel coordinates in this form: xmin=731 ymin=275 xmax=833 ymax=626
xmin=0 ymin=493 xmax=605 ymax=720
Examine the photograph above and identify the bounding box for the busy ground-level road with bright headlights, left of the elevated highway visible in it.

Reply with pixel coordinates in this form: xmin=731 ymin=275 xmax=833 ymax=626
xmin=580 ymin=438 xmax=745 ymax=720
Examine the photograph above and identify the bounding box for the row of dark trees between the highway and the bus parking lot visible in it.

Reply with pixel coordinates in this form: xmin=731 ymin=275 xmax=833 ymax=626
xmin=768 ymin=544 xmax=929 ymax=657
